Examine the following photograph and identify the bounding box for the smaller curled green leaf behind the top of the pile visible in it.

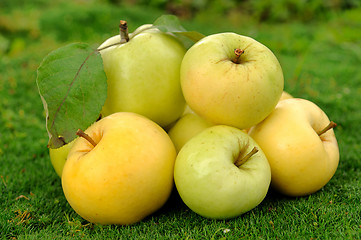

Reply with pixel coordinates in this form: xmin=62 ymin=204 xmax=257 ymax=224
xmin=153 ymin=15 xmax=205 ymax=48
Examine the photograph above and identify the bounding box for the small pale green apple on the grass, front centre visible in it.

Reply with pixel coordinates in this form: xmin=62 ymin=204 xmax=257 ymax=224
xmin=174 ymin=125 xmax=271 ymax=219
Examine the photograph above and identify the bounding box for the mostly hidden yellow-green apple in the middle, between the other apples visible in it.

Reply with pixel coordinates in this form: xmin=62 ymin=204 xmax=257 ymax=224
xmin=168 ymin=113 xmax=213 ymax=152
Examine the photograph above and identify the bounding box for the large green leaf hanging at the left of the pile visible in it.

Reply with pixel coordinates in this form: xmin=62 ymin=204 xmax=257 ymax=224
xmin=36 ymin=43 xmax=107 ymax=148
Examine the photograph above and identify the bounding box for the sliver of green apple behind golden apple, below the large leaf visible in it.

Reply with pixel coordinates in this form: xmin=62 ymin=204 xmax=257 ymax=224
xmin=49 ymin=140 xmax=75 ymax=177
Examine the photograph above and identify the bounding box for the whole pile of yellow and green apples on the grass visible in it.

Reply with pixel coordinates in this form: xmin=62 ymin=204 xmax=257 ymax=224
xmin=50 ymin=20 xmax=339 ymax=225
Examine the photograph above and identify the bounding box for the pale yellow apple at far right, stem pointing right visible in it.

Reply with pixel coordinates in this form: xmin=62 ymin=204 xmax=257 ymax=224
xmin=249 ymin=98 xmax=339 ymax=196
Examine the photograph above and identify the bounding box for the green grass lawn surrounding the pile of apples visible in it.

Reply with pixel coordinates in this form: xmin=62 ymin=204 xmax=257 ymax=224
xmin=0 ymin=1 xmax=361 ymax=239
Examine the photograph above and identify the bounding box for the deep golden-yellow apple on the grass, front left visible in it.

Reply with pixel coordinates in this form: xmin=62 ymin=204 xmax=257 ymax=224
xmin=62 ymin=112 xmax=176 ymax=225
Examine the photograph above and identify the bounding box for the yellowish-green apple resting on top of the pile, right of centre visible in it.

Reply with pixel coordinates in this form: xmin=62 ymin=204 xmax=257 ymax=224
xmin=181 ymin=33 xmax=284 ymax=129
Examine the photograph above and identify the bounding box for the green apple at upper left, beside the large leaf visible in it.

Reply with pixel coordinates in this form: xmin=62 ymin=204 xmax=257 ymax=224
xmin=99 ymin=24 xmax=186 ymax=127
